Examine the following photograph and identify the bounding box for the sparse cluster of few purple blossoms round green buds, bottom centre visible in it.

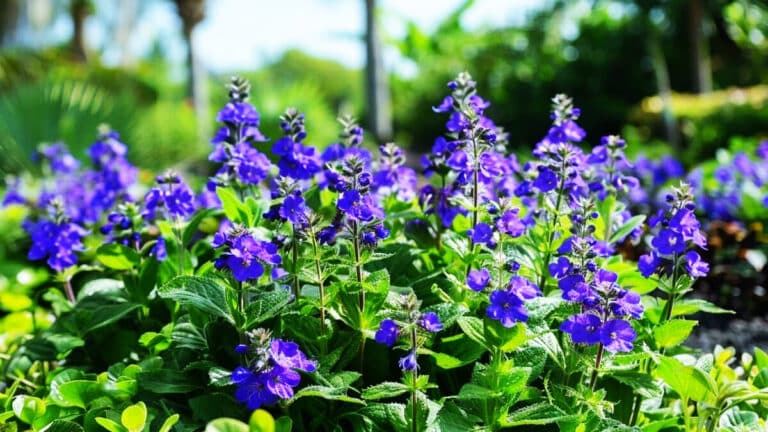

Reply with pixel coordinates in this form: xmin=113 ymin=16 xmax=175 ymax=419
xmin=374 ymin=294 xmax=443 ymax=371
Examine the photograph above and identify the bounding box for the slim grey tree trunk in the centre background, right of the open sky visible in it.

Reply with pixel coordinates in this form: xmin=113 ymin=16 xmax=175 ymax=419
xmin=365 ymin=0 xmax=392 ymax=144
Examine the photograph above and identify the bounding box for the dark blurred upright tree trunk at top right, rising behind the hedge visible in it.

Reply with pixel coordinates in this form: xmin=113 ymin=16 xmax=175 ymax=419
xmin=688 ymin=0 xmax=712 ymax=93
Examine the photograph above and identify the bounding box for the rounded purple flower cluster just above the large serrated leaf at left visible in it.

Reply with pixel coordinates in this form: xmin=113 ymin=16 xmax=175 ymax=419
xmin=212 ymin=225 xmax=282 ymax=282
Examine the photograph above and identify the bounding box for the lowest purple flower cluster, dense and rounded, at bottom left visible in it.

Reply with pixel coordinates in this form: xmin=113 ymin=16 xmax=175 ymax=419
xmin=231 ymin=329 xmax=317 ymax=410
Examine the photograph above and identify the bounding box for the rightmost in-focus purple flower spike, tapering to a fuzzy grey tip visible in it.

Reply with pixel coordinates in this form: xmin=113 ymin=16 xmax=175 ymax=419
xmin=638 ymin=183 xmax=709 ymax=278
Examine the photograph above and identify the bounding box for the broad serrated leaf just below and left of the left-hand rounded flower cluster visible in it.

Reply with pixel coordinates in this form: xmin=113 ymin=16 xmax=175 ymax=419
xmin=157 ymin=276 xmax=235 ymax=324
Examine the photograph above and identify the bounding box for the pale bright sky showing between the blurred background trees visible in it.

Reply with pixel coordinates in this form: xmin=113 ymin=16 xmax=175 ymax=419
xmin=88 ymin=0 xmax=549 ymax=72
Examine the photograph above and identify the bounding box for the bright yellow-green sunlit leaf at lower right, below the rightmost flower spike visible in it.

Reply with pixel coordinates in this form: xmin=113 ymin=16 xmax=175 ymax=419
xmin=656 ymin=357 xmax=717 ymax=402
